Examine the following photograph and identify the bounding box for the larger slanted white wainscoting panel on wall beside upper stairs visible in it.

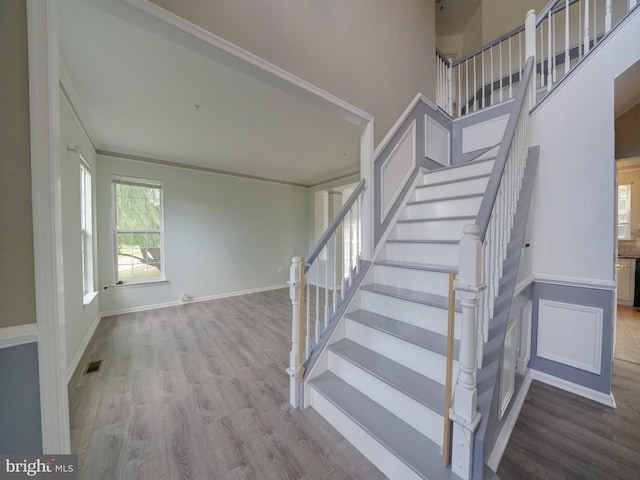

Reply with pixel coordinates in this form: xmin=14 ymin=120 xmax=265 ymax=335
xmin=381 ymin=120 xmax=416 ymax=219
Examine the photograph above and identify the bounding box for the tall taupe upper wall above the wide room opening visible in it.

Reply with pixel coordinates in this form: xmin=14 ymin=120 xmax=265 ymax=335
xmin=152 ymin=0 xmax=436 ymax=144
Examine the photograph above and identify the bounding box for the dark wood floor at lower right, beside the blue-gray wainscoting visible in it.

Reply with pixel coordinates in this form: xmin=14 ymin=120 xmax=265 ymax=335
xmin=497 ymin=360 xmax=640 ymax=480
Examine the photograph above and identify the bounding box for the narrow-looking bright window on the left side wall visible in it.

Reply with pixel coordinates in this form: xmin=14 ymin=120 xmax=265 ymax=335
xmin=80 ymin=161 xmax=95 ymax=304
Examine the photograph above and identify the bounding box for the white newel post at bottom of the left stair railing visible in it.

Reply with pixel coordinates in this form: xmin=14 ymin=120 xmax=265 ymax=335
xmin=287 ymin=257 xmax=304 ymax=407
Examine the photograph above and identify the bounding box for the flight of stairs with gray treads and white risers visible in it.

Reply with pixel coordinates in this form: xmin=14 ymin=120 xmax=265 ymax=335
xmin=308 ymin=154 xmax=495 ymax=479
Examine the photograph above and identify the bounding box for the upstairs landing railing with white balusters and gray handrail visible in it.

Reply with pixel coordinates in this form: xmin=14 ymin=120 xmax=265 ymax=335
xmin=436 ymin=0 xmax=638 ymax=117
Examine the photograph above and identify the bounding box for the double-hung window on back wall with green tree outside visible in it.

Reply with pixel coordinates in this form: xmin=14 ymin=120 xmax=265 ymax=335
xmin=113 ymin=177 xmax=164 ymax=284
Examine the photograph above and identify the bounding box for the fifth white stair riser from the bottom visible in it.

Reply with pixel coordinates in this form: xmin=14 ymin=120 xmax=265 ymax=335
xmin=374 ymin=265 xmax=449 ymax=295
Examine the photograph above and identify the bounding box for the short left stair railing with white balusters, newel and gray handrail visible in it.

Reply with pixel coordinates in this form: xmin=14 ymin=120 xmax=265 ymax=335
xmin=287 ymin=179 xmax=366 ymax=407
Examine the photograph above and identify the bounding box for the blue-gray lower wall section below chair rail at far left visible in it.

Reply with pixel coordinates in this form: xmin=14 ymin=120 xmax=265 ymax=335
xmin=0 ymin=343 xmax=42 ymax=453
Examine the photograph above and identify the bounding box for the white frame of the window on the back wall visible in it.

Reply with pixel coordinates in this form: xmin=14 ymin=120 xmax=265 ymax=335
xmin=111 ymin=175 xmax=167 ymax=287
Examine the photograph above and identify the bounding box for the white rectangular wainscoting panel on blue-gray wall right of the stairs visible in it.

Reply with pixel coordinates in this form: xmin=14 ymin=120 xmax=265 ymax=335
xmin=537 ymin=300 xmax=603 ymax=375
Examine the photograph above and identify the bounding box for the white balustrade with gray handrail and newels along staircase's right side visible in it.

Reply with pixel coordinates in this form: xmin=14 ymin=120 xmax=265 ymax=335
xmin=450 ymin=11 xmax=535 ymax=479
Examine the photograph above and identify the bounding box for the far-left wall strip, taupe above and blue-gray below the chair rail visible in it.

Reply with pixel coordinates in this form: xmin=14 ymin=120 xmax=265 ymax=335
xmin=0 ymin=0 xmax=42 ymax=453
